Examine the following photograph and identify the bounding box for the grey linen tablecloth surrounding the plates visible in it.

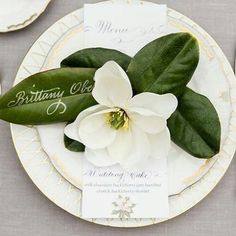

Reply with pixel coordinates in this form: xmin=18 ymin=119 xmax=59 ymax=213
xmin=0 ymin=0 xmax=236 ymax=236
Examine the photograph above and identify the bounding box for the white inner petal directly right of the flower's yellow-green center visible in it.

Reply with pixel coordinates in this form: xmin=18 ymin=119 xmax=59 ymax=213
xmin=128 ymin=108 xmax=166 ymax=134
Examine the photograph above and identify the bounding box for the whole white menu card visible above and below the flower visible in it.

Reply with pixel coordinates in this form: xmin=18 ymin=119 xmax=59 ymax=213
xmin=82 ymin=4 xmax=169 ymax=218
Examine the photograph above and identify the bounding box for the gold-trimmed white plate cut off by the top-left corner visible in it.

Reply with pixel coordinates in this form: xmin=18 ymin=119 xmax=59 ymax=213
xmin=0 ymin=0 xmax=51 ymax=32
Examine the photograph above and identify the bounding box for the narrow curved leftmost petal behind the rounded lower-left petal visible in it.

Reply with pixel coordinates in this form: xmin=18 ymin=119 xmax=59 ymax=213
xmin=64 ymin=105 xmax=106 ymax=142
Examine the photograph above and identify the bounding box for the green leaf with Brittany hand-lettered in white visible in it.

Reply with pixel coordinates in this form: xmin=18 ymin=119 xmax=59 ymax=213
xmin=0 ymin=68 xmax=96 ymax=125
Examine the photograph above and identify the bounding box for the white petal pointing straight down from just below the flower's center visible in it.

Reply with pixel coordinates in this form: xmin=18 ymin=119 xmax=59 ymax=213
xmin=107 ymin=129 xmax=133 ymax=163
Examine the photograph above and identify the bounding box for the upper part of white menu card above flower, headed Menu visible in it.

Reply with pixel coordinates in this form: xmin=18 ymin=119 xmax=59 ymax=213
xmin=84 ymin=4 xmax=167 ymax=56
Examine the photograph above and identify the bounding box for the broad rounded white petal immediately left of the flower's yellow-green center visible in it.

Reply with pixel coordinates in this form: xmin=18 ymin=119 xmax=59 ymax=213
xmin=79 ymin=109 xmax=117 ymax=149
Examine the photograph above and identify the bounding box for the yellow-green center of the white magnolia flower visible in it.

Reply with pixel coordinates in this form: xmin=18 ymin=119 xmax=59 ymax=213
xmin=108 ymin=109 xmax=129 ymax=130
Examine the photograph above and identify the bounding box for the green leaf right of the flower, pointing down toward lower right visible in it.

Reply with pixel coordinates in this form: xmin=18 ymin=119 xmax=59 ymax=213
xmin=168 ymin=88 xmax=221 ymax=158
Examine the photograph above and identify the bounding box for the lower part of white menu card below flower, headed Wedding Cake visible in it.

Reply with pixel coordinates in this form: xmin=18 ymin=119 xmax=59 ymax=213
xmin=82 ymin=158 xmax=169 ymax=218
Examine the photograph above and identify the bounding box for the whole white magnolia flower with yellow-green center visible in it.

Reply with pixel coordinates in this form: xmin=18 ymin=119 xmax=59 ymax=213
xmin=65 ymin=61 xmax=177 ymax=169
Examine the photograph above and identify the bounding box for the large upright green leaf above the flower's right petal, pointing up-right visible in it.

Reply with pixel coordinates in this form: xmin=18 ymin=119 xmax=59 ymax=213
xmin=127 ymin=33 xmax=199 ymax=96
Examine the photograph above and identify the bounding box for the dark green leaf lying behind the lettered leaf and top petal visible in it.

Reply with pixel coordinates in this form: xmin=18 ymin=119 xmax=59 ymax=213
xmin=61 ymin=48 xmax=131 ymax=70
